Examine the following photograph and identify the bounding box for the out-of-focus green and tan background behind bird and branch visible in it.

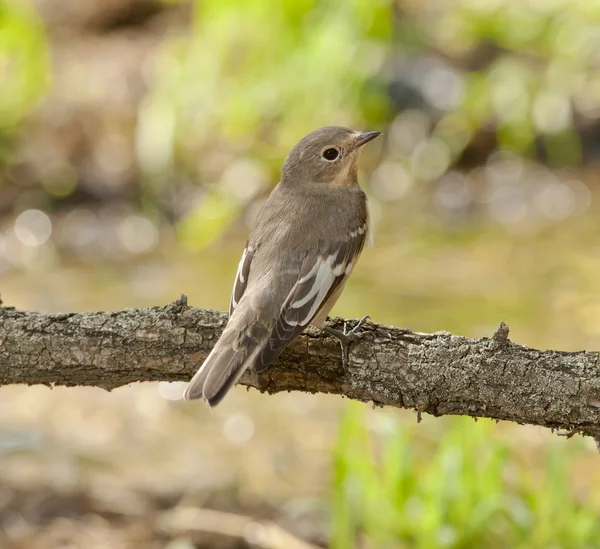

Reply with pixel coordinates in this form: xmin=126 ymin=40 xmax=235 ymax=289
xmin=0 ymin=0 xmax=600 ymax=549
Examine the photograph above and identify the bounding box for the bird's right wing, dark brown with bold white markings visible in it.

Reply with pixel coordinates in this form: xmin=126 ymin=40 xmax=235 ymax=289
xmin=256 ymin=226 xmax=367 ymax=372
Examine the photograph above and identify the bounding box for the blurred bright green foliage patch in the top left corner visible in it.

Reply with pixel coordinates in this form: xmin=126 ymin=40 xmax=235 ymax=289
xmin=0 ymin=0 xmax=50 ymax=134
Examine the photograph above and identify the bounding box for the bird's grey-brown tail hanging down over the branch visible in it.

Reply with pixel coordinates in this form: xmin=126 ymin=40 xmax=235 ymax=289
xmin=183 ymin=303 xmax=269 ymax=407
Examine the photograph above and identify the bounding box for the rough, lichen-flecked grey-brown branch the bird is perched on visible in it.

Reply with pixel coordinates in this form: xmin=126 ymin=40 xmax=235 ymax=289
xmin=0 ymin=296 xmax=600 ymax=439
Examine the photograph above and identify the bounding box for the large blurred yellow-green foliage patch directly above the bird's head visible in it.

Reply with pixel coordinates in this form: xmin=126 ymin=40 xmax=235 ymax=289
xmin=137 ymin=0 xmax=391 ymax=247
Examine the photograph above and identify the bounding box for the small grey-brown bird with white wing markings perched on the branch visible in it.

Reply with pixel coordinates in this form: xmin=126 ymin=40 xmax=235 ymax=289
xmin=183 ymin=126 xmax=381 ymax=407
